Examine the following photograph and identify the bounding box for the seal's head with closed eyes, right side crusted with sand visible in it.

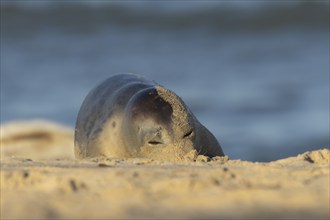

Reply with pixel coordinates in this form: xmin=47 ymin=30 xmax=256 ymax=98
xmin=123 ymin=86 xmax=217 ymax=159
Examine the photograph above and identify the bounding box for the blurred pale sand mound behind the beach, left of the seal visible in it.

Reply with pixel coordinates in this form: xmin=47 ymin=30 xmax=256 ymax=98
xmin=0 ymin=120 xmax=74 ymax=159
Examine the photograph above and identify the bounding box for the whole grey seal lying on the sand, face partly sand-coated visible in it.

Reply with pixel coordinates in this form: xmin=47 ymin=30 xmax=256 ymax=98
xmin=74 ymin=74 xmax=224 ymax=159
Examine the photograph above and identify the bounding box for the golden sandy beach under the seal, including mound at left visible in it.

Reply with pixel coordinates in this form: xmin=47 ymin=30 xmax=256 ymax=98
xmin=1 ymin=121 xmax=330 ymax=219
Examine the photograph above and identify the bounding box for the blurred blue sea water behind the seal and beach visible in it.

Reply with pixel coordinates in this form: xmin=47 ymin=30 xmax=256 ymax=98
xmin=1 ymin=1 xmax=329 ymax=161
